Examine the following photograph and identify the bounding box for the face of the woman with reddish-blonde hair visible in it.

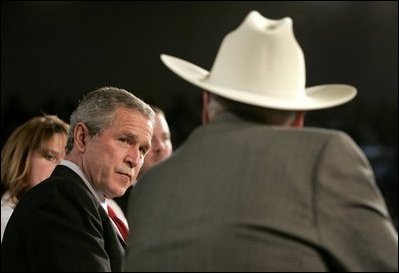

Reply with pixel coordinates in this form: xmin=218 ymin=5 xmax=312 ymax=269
xmin=27 ymin=133 xmax=67 ymax=188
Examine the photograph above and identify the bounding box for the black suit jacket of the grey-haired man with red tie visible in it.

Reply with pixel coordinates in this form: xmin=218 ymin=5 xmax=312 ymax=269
xmin=1 ymin=166 xmax=124 ymax=272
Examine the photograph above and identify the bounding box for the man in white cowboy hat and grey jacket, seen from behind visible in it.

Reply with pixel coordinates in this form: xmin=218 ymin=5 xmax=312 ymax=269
xmin=125 ymin=11 xmax=398 ymax=272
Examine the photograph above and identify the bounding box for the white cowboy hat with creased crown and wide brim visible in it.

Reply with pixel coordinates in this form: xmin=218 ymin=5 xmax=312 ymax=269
xmin=161 ymin=11 xmax=357 ymax=110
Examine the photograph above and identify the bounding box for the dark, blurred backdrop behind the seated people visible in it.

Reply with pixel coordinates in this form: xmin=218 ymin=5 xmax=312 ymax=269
xmin=1 ymin=1 xmax=398 ymax=225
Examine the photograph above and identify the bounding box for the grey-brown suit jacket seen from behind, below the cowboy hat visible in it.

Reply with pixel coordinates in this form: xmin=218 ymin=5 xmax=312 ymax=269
xmin=126 ymin=114 xmax=398 ymax=271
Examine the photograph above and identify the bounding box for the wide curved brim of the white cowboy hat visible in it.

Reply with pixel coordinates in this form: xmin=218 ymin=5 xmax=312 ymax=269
xmin=161 ymin=54 xmax=357 ymax=110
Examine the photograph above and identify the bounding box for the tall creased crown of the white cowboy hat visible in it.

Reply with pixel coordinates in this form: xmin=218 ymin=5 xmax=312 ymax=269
xmin=204 ymin=11 xmax=305 ymax=98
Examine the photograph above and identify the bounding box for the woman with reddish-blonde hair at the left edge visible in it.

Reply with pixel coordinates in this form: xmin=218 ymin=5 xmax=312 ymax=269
xmin=1 ymin=115 xmax=69 ymax=241
